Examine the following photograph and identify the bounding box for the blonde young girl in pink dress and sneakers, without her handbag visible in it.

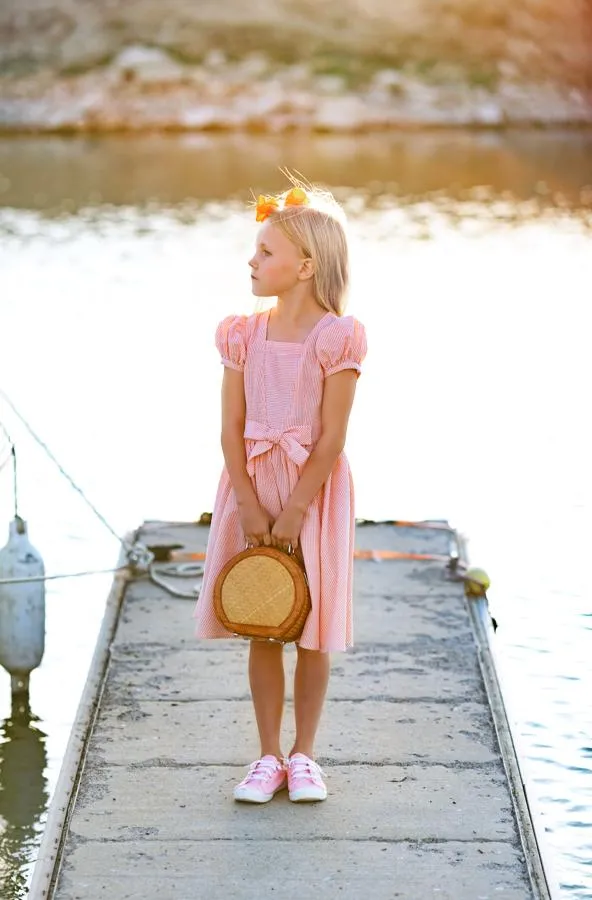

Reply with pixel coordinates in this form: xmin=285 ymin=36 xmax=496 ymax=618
xmin=195 ymin=179 xmax=366 ymax=803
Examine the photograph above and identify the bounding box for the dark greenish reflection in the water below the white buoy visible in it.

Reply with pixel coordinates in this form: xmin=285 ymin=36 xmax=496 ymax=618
xmin=0 ymin=698 xmax=48 ymax=897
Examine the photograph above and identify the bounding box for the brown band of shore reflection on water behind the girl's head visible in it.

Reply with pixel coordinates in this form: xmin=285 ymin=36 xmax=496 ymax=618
xmin=0 ymin=131 xmax=592 ymax=211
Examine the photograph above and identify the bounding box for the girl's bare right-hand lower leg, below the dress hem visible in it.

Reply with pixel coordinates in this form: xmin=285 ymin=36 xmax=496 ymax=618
xmin=290 ymin=647 xmax=331 ymax=759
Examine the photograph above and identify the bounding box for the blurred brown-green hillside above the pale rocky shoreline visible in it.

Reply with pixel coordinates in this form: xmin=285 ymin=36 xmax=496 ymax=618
xmin=0 ymin=0 xmax=592 ymax=87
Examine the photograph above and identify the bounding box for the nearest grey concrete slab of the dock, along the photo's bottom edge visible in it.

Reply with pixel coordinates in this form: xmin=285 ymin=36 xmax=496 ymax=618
xmin=53 ymin=840 xmax=531 ymax=900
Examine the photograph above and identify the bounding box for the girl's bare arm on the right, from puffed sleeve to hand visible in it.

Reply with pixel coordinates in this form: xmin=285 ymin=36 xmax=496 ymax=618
xmin=272 ymin=369 xmax=358 ymax=547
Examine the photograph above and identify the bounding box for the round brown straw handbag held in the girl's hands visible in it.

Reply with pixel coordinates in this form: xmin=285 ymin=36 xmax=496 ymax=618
xmin=214 ymin=547 xmax=311 ymax=643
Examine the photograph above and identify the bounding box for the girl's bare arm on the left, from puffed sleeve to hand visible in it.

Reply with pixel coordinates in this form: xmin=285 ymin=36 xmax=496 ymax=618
xmin=221 ymin=368 xmax=272 ymax=544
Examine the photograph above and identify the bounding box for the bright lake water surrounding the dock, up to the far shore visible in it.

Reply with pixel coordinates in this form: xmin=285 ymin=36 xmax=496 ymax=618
xmin=0 ymin=131 xmax=592 ymax=900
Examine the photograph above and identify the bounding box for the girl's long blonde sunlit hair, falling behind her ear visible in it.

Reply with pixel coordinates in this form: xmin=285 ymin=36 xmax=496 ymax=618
xmin=262 ymin=176 xmax=349 ymax=316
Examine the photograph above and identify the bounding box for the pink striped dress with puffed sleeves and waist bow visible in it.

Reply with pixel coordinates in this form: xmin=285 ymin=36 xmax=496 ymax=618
xmin=194 ymin=311 xmax=366 ymax=651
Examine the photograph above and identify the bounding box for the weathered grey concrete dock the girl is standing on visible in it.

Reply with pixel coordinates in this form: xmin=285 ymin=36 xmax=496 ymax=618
xmin=29 ymin=523 xmax=549 ymax=900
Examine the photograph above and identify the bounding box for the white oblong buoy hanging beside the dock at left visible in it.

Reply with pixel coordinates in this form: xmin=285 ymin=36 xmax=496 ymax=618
xmin=0 ymin=516 xmax=45 ymax=695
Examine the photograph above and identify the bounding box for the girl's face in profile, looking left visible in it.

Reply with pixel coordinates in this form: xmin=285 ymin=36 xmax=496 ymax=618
xmin=249 ymin=222 xmax=304 ymax=297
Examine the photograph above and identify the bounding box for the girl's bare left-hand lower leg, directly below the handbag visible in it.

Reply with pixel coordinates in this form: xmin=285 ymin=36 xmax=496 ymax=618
xmin=249 ymin=641 xmax=284 ymax=760
